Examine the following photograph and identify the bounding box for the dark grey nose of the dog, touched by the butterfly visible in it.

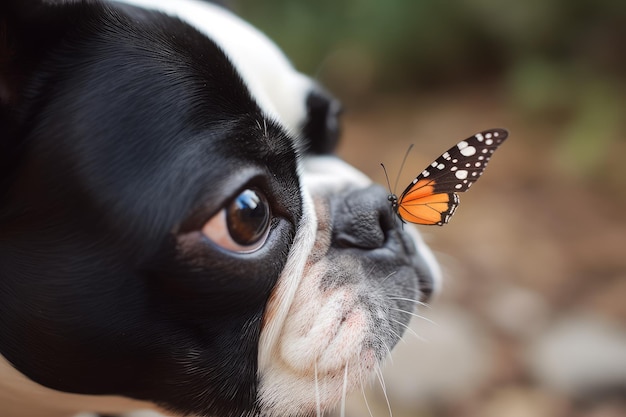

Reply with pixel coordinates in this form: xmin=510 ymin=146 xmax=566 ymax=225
xmin=332 ymin=185 xmax=396 ymax=249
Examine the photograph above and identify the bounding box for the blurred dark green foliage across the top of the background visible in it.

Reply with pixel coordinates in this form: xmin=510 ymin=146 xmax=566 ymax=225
xmin=236 ymin=0 xmax=626 ymax=182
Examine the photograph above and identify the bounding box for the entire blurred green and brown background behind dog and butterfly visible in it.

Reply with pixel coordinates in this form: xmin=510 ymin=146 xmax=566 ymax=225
xmin=232 ymin=0 xmax=626 ymax=417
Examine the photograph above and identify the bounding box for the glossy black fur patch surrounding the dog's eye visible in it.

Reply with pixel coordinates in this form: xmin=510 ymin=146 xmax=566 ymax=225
xmin=0 ymin=3 xmax=302 ymax=416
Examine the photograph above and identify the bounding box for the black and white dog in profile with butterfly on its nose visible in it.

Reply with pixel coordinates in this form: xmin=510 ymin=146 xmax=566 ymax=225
xmin=0 ymin=0 xmax=439 ymax=417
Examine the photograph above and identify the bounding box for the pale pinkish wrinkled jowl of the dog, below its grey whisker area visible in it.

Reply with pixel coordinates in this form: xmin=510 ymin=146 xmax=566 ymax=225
xmin=259 ymin=261 xmax=396 ymax=416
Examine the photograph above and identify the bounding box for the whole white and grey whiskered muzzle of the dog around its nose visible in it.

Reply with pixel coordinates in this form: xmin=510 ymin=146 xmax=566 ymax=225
xmin=258 ymin=157 xmax=439 ymax=417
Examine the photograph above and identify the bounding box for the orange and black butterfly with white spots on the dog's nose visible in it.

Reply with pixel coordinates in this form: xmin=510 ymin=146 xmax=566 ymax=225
xmin=383 ymin=129 xmax=509 ymax=226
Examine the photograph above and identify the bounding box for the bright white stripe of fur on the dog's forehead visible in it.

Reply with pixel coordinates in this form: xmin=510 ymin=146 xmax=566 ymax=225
xmin=109 ymin=0 xmax=314 ymax=132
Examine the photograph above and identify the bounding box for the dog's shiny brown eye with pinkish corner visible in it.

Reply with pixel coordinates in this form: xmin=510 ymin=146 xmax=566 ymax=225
xmin=202 ymin=189 xmax=271 ymax=253
